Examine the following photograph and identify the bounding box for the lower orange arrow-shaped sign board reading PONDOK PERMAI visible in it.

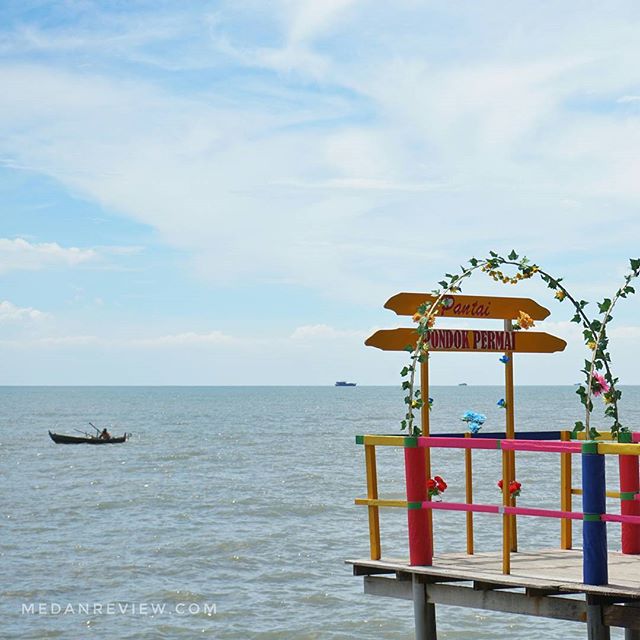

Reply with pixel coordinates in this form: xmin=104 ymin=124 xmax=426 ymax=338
xmin=365 ymin=328 xmax=567 ymax=353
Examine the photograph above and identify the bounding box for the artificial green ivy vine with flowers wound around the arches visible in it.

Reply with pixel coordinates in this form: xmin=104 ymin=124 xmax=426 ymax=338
xmin=400 ymin=251 xmax=640 ymax=439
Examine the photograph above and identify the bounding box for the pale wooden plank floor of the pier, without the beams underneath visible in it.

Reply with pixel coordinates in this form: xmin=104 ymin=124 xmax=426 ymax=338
xmin=347 ymin=549 xmax=640 ymax=599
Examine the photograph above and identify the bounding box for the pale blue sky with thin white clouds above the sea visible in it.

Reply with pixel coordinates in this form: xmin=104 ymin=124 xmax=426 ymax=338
xmin=0 ymin=0 xmax=640 ymax=385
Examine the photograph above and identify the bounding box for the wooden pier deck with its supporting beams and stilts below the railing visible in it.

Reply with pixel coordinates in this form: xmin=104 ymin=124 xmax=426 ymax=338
xmin=347 ymin=549 xmax=640 ymax=640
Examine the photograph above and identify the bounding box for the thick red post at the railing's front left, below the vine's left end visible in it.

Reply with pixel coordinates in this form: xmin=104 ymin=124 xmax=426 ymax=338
xmin=404 ymin=438 xmax=433 ymax=566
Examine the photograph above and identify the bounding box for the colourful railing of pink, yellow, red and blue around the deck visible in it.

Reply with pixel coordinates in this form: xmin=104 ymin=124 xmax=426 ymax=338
xmin=355 ymin=431 xmax=640 ymax=585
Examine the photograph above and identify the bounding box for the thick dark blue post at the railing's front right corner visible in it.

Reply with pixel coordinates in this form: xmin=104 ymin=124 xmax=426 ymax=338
xmin=582 ymin=441 xmax=609 ymax=585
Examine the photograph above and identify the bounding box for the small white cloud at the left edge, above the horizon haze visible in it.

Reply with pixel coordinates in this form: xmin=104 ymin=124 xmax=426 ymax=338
xmin=0 ymin=238 xmax=98 ymax=274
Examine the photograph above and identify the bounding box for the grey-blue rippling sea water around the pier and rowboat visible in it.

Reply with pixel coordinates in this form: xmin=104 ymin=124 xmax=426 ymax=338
xmin=0 ymin=387 xmax=640 ymax=640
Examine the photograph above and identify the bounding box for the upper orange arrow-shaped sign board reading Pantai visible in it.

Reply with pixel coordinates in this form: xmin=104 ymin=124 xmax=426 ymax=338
xmin=384 ymin=293 xmax=549 ymax=320
